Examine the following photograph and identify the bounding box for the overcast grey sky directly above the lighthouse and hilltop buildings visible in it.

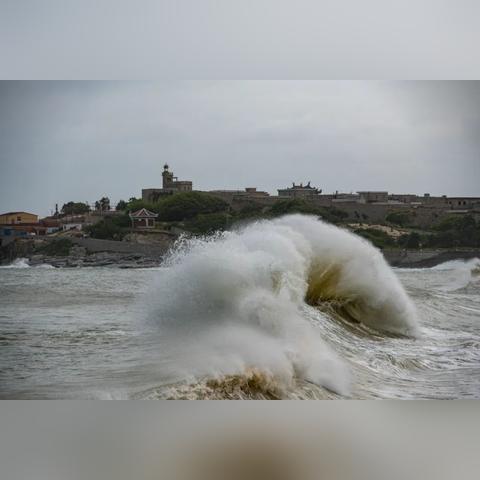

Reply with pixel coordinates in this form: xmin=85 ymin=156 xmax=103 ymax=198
xmin=0 ymin=81 xmax=480 ymax=215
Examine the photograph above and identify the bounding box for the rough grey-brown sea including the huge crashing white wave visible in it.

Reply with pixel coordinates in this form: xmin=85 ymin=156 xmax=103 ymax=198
xmin=0 ymin=215 xmax=480 ymax=399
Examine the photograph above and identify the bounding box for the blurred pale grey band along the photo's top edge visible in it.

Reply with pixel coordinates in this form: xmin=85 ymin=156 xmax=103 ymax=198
xmin=0 ymin=0 xmax=480 ymax=79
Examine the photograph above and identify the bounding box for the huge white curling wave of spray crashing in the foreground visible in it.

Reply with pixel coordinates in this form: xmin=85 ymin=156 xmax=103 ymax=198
xmin=149 ymin=215 xmax=417 ymax=394
